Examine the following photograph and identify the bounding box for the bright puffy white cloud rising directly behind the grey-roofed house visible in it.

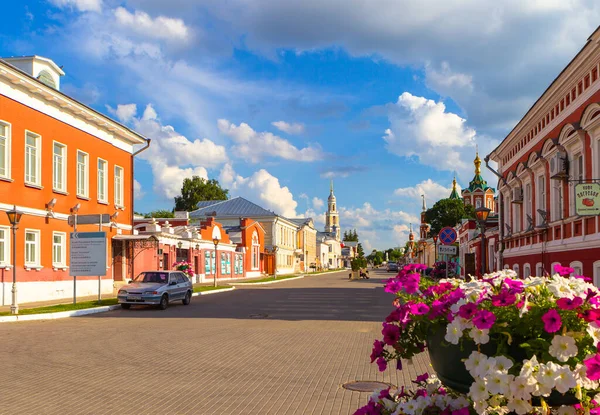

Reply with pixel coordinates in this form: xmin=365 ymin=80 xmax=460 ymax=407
xmin=220 ymin=163 xmax=298 ymax=218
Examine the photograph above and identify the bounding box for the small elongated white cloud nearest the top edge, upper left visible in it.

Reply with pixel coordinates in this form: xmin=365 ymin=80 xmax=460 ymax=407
xmin=114 ymin=7 xmax=191 ymax=41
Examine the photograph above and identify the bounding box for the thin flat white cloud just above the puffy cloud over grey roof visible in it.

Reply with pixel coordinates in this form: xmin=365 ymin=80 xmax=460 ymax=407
xmin=217 ymin=119 xmax=325 ymax=163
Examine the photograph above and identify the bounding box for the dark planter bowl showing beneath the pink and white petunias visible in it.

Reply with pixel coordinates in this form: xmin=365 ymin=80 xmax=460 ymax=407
xmin=427 ymin=326 xmax=579 ymax=406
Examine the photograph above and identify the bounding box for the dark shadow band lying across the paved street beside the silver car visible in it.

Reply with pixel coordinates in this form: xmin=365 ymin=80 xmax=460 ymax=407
xmin=89 ymin=278 xmax=394 ymax=322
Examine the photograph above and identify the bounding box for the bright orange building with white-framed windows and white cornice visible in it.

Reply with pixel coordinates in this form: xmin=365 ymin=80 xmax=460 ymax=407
xmin=0 ymin=56 xmax=150 ymax=305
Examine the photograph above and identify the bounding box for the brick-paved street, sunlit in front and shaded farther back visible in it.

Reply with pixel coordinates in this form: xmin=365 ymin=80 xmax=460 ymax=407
xmin=0 ymin=272 xmax=427 ymax=414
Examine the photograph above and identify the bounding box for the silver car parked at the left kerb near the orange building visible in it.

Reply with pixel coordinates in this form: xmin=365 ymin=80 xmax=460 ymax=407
xmin=117 ymin=271 xmax=194 ymax=310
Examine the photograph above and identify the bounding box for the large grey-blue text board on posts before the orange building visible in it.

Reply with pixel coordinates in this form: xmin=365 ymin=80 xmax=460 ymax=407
xmin=69 ymin=232 xmax=106 ymax=277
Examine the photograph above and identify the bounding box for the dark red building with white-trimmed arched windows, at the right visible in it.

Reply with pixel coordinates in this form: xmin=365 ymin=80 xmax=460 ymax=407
xmin=488 ymin=28 xmax=600 ymax=285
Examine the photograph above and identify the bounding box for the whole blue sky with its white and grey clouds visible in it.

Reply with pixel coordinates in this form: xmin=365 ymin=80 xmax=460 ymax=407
xmin=0 ymin=0 xmax=600 ymax=249
